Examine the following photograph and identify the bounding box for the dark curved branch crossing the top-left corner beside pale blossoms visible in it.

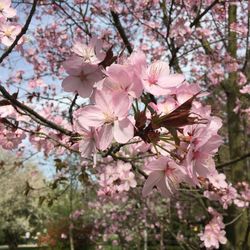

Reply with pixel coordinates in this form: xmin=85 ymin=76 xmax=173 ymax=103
xmin=0 ymin=0 xmax=38 ymax=64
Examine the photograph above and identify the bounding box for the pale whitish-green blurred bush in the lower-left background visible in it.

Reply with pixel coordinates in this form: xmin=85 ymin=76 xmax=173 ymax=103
xmin=0 ymin=152 xmax=45 ymax=245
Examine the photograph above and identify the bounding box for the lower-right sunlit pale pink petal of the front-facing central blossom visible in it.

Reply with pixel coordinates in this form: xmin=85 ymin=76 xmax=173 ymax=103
xmin=114 ymin=118 xmax=134 ymax=143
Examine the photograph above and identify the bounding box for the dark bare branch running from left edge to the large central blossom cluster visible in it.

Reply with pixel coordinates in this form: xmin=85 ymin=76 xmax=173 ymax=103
xmin=0 ymin=85 xmax=73 ymax=136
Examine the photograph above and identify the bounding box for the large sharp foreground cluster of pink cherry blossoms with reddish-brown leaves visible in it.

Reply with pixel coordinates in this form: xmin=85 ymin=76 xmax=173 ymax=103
xmin=62 ymin=38 xmax=225 ymax=201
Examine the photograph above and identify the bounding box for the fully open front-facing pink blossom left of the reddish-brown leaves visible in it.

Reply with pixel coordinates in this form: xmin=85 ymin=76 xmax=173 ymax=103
xmin=77 ymin=91 xmax=134 ymax=150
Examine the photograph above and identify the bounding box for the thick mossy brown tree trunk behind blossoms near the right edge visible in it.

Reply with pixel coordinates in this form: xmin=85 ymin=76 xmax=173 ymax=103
xmin=224 ymin=4 xmax=250 ymax=250
